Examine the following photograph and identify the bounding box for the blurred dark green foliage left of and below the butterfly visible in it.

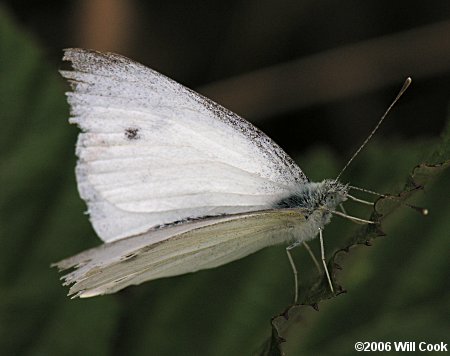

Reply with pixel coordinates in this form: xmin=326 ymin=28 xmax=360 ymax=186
xmin=0 ymin=6 xmax=450 ymax=355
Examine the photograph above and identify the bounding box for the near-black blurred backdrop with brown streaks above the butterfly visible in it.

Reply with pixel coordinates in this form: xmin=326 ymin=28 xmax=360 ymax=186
xmin=6 ymin=0 xmax=450 ymax=157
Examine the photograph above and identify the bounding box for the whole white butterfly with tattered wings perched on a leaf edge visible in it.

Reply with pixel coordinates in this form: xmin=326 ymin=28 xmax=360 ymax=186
xmin=55 ymin=49 xmax=412 ymax=301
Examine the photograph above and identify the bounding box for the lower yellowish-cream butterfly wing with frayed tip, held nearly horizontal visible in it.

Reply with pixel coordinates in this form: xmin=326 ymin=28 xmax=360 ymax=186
xmin=55 ymin=209 xmax=309 ymax=297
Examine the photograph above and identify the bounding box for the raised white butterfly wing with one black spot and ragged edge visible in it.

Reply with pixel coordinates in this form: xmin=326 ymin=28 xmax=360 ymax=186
xmin=62 ymin=49 xmax=307 ymax=241
